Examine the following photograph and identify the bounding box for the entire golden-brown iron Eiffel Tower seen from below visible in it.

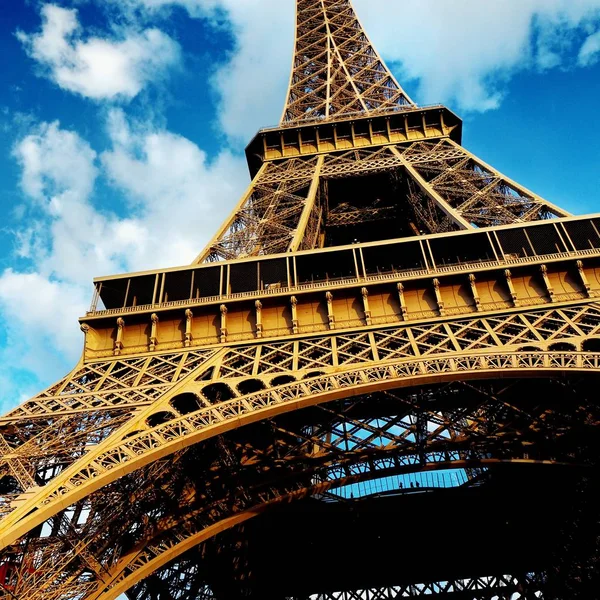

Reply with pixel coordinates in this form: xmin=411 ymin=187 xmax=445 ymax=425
xmin=0 ymin=0 xmax=600 ymax=600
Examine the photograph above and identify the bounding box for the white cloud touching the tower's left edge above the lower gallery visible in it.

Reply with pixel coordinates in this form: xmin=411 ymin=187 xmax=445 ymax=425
xmin=102 ymin=110 xmax=249 ymax=269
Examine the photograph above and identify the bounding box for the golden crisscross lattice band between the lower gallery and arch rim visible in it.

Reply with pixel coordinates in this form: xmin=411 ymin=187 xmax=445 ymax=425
xmin=4 ymin=304 xmax=600 ymax=528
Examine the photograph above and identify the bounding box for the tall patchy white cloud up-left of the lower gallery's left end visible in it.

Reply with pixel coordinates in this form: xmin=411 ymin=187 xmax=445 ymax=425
xmin=14 ymin=122 xmax=123 ymax=284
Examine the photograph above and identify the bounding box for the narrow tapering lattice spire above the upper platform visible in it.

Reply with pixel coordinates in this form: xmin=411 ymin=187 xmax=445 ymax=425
xmin=281 ymin=0 xmax=415 ymax=125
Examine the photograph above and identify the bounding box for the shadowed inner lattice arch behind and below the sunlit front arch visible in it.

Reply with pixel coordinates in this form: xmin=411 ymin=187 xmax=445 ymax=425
xmin=4 ymin=373 xmax=600 ymax=600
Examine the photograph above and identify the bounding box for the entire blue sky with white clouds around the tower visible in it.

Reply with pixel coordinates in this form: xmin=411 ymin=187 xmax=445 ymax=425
xmin=0 ymin=0 xmax=600 ymax=412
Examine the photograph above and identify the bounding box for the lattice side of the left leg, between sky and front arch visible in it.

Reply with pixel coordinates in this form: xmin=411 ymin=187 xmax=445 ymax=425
xmin=0 ymin=350 xmax=216 ymax=514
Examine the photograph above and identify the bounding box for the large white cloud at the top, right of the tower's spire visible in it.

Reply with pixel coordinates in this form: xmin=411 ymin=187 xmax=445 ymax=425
xmin=355 ymin=0 xmax=600 ymax=111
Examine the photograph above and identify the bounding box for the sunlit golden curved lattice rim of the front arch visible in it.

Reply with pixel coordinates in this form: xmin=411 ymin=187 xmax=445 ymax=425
xmin=0 ymin=352 xmax=600 ymax=549
